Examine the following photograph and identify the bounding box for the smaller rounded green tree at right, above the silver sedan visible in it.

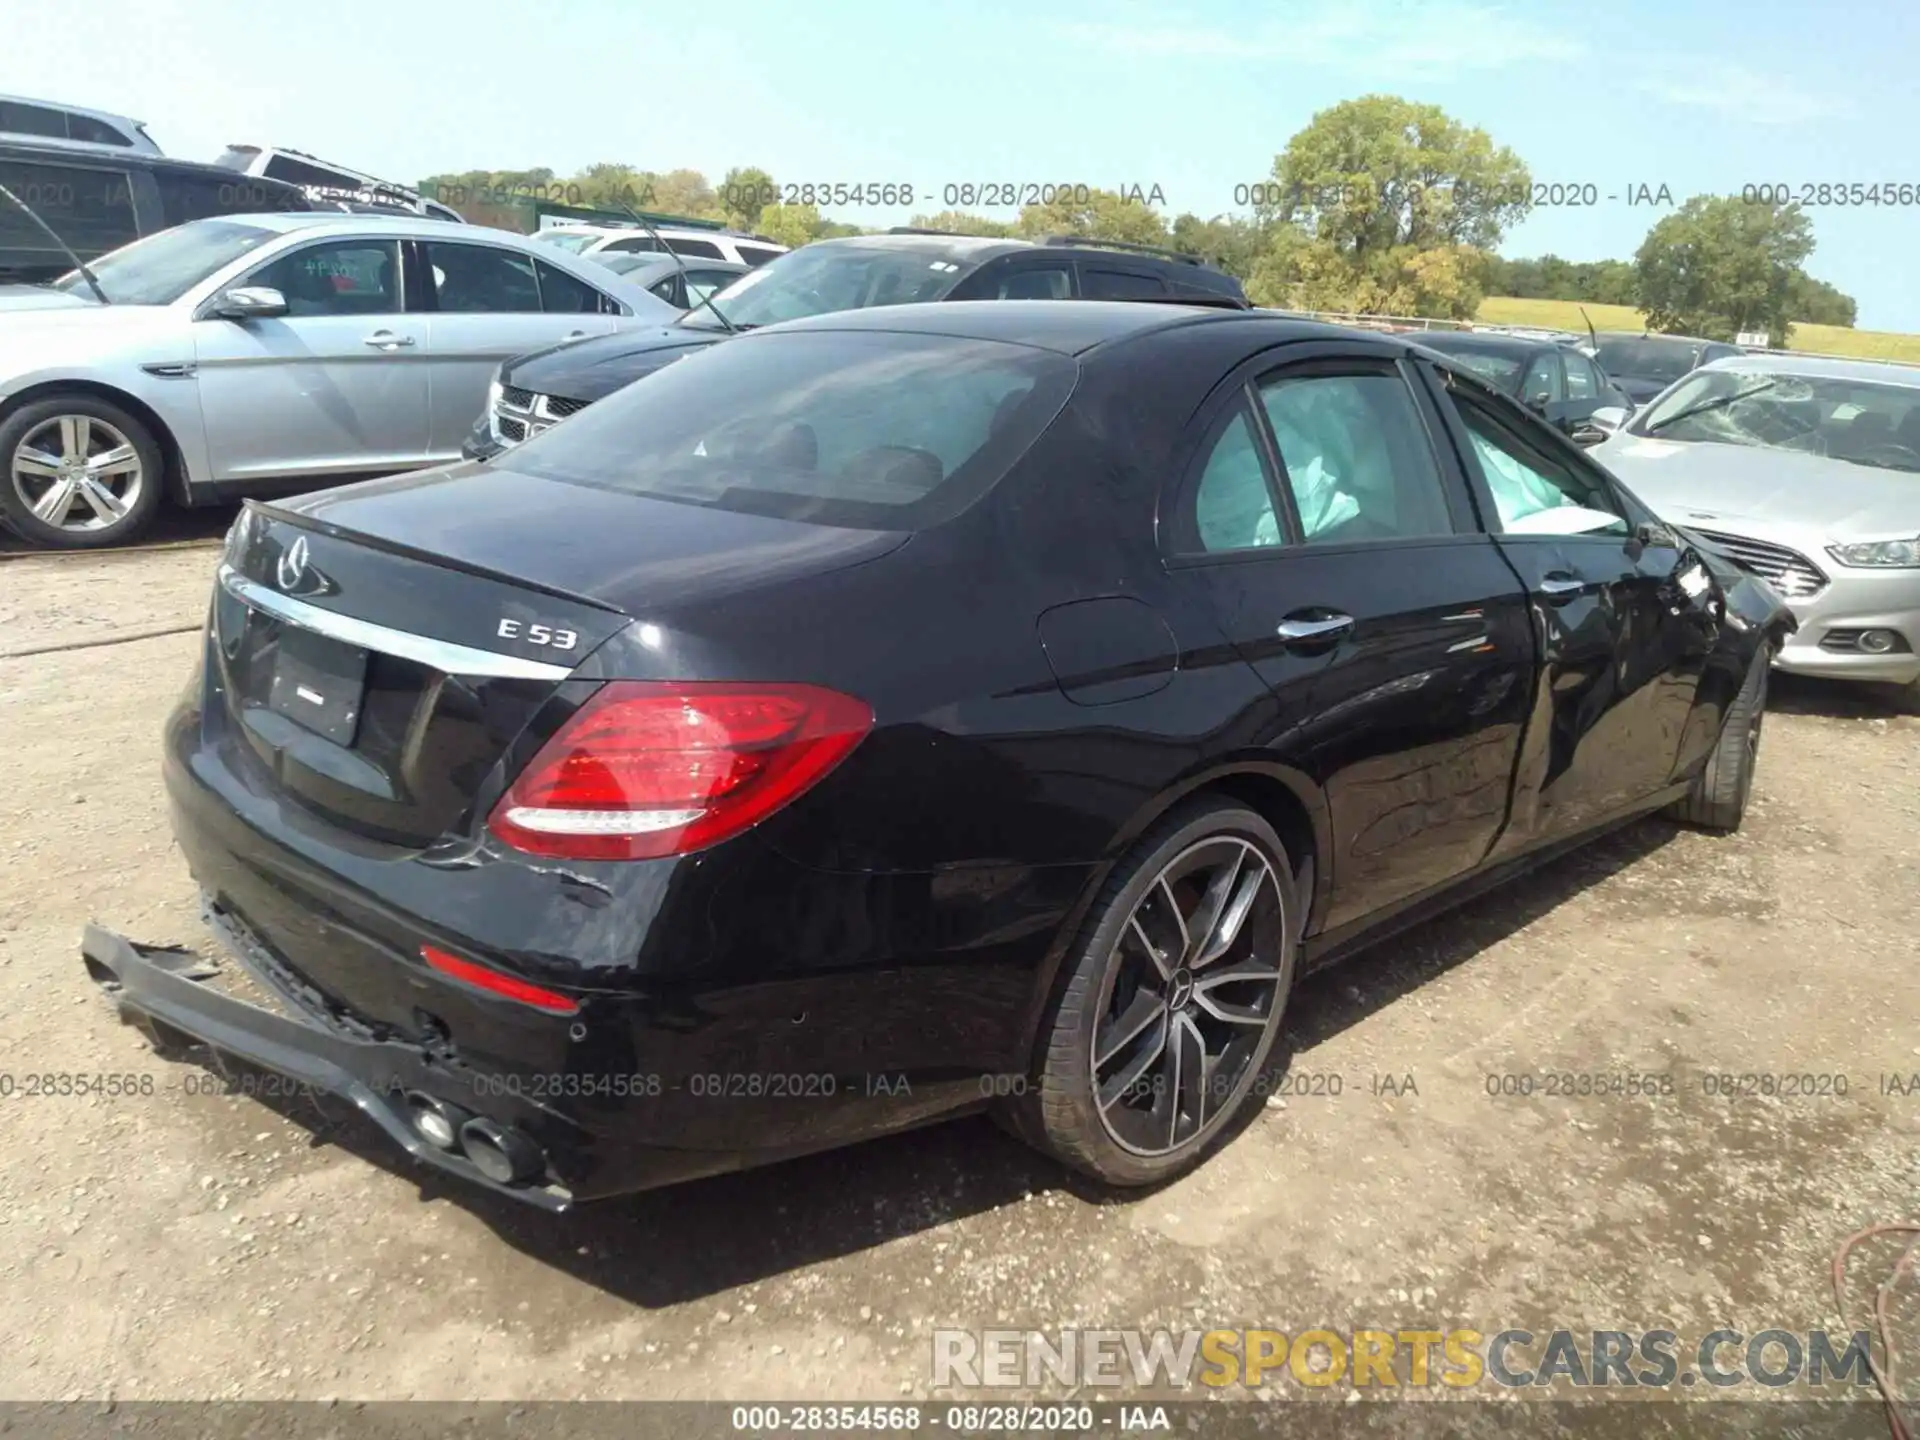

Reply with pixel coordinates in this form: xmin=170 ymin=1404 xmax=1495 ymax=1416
xmin=1634 ymin=196 xmax=1812 ymax=348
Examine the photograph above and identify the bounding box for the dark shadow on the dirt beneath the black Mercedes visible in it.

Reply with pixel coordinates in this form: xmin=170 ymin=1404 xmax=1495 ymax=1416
xmin=191 ymin=820 xmax=1678 ymax=1309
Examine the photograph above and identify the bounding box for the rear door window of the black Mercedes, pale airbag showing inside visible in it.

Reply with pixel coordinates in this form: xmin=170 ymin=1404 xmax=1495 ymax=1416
xmin=1260 ymin=371 xmax=1453 ymax=545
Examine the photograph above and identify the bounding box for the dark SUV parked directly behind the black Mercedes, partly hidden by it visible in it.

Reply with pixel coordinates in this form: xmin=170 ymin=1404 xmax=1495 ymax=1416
xmin=461 ymin=228 xmax=1250 ymax=459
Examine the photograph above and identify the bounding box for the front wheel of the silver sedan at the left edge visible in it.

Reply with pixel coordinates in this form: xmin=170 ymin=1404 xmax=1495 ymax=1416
xmin=0 ymin=390 xmax=165 ymax=549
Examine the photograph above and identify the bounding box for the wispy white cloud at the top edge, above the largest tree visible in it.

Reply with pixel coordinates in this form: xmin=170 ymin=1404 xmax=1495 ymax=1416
xmin=1058 ymin=0 xmax=1584 ymax=83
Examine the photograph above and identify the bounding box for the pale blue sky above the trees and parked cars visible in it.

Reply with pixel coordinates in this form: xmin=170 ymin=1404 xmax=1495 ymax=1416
xmin=15 ymin=0 xmax=1920 ymax=330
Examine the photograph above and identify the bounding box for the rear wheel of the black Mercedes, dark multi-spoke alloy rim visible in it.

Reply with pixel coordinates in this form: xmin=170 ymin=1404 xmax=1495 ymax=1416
xmin=1012 ymin=797 xmax=1300 ymax=1187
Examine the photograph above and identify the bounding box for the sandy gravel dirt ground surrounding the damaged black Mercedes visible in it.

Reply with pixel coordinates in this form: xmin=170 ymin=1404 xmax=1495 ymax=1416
xmin=0 ymin=549 xmax=1920 ymax=1400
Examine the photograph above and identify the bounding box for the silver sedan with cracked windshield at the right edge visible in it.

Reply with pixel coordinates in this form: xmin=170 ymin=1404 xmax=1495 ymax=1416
xmin=1590 ymin=355 xmax=1920 ymax=705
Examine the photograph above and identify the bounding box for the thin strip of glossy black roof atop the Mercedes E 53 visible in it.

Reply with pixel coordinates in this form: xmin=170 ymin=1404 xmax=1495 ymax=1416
xmin=755 ymin=301 xmax=1351 ymax=355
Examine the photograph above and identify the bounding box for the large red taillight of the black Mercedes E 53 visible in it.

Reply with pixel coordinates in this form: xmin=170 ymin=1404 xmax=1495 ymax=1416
xmin=488 ymin=680 xmax=874 ymax=860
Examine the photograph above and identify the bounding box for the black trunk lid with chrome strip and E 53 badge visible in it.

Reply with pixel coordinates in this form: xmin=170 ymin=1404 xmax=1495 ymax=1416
xmin=213 ymin=480 xmax=904 ymax=849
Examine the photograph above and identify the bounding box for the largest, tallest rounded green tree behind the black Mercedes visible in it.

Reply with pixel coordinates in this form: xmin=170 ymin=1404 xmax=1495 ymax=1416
xmin=1256 ymin=94 xmax=1530 ymax=317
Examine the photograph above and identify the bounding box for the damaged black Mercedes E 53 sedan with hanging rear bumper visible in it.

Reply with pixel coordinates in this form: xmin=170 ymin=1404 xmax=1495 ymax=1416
xmin=84 ymin=301 xmax=1791 ymax=1208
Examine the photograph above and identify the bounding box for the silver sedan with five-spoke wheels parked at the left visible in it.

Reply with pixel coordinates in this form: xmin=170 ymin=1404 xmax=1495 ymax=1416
xmin=0 ymin=213 xmax=680 ymax=549
